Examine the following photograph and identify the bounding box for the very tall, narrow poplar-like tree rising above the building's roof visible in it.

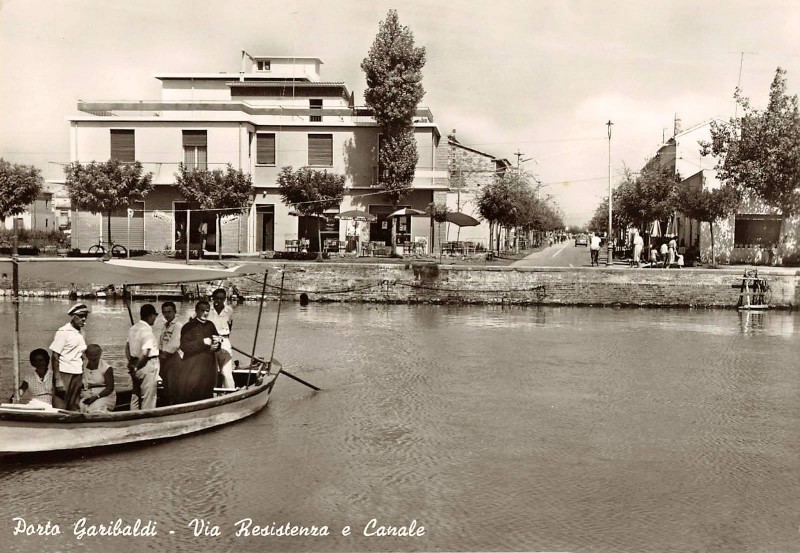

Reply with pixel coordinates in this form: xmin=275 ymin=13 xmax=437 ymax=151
xmin=361 ymin=10 xmax=425 ymax=245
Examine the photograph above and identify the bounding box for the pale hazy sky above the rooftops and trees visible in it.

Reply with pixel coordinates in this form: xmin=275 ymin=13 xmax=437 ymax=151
xmin=0 ymin=0 xmax=800 ymax=225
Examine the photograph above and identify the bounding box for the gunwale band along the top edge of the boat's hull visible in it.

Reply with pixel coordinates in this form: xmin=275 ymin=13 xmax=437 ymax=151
xmin=0 ymin=360 xmax=280 ymax=424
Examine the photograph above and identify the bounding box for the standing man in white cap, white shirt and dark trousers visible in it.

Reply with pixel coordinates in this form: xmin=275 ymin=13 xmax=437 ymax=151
xmin=50 ymin=303 xmax=89 ymax=411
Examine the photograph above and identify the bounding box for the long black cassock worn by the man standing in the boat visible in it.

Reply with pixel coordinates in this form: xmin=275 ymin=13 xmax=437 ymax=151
xmin=167 ymin=319 xmax=217 ymax=405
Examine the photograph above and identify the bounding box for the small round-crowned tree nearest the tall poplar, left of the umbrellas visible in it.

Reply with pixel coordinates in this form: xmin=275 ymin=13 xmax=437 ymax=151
xmin=278 ymin=167 xmax=345 ymax=259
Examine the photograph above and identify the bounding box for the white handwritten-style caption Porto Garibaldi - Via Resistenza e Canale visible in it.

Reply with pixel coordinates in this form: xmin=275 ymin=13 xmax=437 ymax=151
xmin=11 ymin=517 xmax=425 ymax=540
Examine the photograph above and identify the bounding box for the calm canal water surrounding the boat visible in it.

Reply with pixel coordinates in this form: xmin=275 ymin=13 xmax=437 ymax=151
xmin=0 ymin=300 xmax=800 ymax=552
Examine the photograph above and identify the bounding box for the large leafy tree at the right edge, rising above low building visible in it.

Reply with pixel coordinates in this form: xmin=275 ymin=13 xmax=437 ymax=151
xmin=702 ymin=67 xmax=800 ymax=258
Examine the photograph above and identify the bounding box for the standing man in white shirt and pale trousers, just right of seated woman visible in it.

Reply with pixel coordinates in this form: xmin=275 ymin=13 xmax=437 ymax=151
xmin=125 ymin=303 xmax=159 ymax=411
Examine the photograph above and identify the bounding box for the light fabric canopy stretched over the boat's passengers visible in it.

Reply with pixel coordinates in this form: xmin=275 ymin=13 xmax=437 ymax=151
xmin=0 ymin=257 xmax=264 ymax=286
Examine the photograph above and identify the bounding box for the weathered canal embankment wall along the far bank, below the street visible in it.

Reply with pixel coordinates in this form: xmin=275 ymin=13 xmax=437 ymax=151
xmin=0 ymin=262 xmax=800 ymax=309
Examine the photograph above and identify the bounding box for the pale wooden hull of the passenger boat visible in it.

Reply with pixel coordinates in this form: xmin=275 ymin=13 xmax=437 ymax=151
xmin=0 ymin=373 xmax=278 ymax=455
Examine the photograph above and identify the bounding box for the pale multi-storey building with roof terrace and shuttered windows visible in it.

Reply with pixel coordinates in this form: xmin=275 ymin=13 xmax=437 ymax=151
xmin=69 ymin=52 xmax=448 ymax=252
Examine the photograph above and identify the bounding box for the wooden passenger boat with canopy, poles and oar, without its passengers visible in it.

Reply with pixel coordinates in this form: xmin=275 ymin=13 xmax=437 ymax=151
xmin=0 ymin=254 xmax=310 ymax=455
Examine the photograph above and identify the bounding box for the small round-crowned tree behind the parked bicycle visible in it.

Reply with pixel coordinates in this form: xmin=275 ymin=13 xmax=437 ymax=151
xmin=64 ymin=159 xmax=154 ymax=251
